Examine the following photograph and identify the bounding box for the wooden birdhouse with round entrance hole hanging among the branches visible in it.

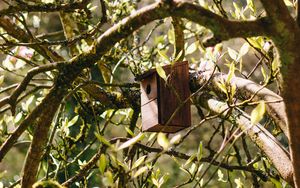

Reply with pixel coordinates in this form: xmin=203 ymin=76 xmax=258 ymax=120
xmin=138 ymin=61 xmax=191 ymax=133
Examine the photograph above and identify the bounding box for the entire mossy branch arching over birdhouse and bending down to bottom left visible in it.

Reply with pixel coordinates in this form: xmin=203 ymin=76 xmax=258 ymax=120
xmin=0 ymin=1 xmax=276 ymax=187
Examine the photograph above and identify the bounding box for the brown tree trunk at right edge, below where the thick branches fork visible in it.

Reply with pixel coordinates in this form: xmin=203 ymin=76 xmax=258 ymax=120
xmin=275 ymin=35 xmax=300 ymax=187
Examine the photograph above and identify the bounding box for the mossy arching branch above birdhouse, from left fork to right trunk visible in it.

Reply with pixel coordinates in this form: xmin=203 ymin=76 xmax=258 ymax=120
xmin=70 ymin=0 xmax=269 ymax=69
